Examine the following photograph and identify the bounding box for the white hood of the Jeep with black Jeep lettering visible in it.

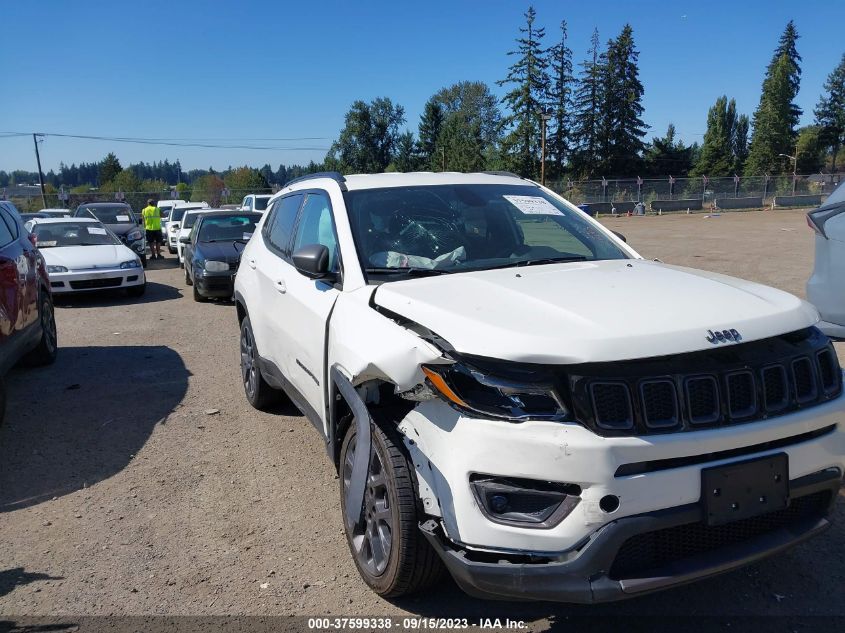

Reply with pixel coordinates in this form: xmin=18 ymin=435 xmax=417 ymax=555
xmin=374 ymin=259 xmax=818 ymax=364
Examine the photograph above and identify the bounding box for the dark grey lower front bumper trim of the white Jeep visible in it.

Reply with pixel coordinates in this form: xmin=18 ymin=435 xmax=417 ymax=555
xmin=421 ymin=469 xmax=841 ymax=603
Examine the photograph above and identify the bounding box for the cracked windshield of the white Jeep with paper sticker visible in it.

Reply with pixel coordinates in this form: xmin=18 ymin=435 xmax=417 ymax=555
xmin=346 ymin=184 xmax=628 ymax=276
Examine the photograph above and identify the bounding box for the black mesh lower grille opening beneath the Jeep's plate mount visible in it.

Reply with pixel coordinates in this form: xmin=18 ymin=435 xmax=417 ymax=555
xmin=610 ymin=490 xmax=830 ymax=580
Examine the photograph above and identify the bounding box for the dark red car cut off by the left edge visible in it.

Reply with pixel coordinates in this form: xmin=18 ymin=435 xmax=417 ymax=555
xmin=0 ymin=201 xmax=57 ymax=424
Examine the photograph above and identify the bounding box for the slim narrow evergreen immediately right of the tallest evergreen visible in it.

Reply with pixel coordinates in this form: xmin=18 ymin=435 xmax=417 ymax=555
xmin=546 ymin=20 xmax=574 ymax=178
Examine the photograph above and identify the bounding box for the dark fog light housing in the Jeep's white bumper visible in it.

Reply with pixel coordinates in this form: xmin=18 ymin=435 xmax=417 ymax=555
xmin=470 ymin=474 xmax=581 ymax=529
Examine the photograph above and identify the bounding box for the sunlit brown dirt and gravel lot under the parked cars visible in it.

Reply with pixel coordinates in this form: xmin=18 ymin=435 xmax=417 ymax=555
xmin=0 ymin=211 xmax=845 ymax=629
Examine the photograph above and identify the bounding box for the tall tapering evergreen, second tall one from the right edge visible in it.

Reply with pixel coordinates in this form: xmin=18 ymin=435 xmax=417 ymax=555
xmin=745 ymin=53 xmax=795 ymax=176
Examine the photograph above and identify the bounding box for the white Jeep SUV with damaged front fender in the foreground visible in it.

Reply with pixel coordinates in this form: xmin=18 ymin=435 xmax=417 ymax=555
xmin=235 ymin=173 xmax=845 ymax=602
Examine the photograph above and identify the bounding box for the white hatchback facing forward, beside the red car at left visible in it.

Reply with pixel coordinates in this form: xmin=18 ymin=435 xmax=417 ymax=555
xmin=26 ymin=218 xmax=147 ymax=297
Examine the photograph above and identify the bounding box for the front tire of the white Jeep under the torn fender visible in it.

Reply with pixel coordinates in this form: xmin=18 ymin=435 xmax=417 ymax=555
xmin=339 ymin=421 xmax=443 ymax=598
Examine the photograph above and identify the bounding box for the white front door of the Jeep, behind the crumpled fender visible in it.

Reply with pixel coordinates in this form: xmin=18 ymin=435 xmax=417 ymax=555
xmin=268 ymin=190 xmax=340 ymax=432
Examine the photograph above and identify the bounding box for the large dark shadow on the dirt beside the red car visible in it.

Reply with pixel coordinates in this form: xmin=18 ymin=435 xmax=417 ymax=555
xmin=0 ymin=346 xmax=190 ymax=512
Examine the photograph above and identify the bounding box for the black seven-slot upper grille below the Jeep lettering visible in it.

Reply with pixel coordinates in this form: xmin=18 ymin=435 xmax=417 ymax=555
xmin=570 ymin=328 xmax=841 ymax=434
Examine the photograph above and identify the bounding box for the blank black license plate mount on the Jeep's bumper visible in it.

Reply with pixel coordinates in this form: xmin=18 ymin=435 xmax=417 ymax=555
xmin=701 ymin=453 xmax=789 ymax=525
